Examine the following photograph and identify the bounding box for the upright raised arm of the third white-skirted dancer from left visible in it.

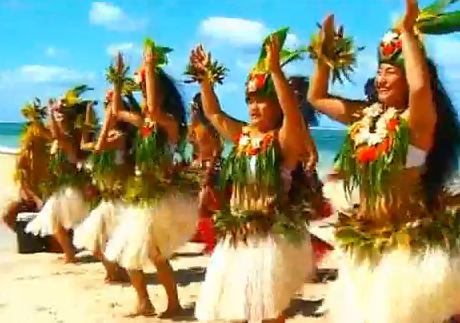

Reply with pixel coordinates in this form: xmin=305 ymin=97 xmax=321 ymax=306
xmin=144 ymin=47 xmax=179 ymax=143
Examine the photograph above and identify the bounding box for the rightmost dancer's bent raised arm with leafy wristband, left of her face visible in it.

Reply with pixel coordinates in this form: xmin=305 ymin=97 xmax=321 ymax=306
xmin=308 ymin=15 xmax=365 ymax=124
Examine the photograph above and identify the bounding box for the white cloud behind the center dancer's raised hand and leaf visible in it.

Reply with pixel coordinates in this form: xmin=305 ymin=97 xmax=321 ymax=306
xmin=199 ymin=17 xmax=299 ymax=48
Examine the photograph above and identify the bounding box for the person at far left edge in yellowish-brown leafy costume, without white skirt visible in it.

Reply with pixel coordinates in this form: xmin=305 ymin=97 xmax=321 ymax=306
xmin=2 ymin=99 xmax=51 ymax=231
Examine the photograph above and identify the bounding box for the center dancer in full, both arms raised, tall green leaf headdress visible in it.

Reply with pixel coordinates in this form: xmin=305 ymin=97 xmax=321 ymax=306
xmin=191 ymin=28 xmax=314 ymax=322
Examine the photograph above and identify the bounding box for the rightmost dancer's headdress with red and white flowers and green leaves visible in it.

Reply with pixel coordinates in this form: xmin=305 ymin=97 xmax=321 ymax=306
xmin=378 ymin=0 xmax=460 ymax=66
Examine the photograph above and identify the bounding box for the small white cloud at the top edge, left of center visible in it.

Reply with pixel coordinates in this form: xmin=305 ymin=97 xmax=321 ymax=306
xmin=89 ymin=2 xmax=147 ymax=31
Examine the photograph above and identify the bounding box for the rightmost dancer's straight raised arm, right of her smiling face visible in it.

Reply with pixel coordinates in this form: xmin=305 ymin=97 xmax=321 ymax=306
xmin=401 ymin=0 xmax=436 ymax=150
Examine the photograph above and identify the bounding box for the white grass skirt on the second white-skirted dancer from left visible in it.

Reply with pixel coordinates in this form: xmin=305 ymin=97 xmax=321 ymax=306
xmin=73 ymin=200 xmax=123 ymax=253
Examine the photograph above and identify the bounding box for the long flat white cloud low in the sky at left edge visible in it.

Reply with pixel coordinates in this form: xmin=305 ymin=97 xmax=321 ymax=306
xmin=0 ymin=65 xmax=95 ymax=87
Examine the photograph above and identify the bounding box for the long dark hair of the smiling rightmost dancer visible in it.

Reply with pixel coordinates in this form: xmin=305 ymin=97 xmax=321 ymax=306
xmin=365 ymin=59 xmax=460 ymax=211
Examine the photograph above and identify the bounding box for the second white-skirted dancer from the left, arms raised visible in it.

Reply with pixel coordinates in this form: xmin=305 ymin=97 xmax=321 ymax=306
xmin=73 ymin=54 xmax=136 ymax=283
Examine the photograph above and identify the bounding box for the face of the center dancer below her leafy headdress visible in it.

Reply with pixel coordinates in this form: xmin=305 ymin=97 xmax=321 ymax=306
xmin=248 ymin=96 xmax=283 ymax=132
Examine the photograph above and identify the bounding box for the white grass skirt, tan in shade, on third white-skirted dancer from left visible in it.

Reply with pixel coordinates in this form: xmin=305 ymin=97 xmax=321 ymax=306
xmin=105 ymin=195 xmax=198 ymax=270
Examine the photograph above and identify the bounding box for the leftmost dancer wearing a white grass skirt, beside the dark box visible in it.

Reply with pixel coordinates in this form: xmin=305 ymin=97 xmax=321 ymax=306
xmin=26 ymin=85 xmax=94 ymax=263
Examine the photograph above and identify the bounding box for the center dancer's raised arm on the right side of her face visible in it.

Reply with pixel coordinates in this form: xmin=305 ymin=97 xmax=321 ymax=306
xmin=266 ymin=36 xmax=309 ymax=162
